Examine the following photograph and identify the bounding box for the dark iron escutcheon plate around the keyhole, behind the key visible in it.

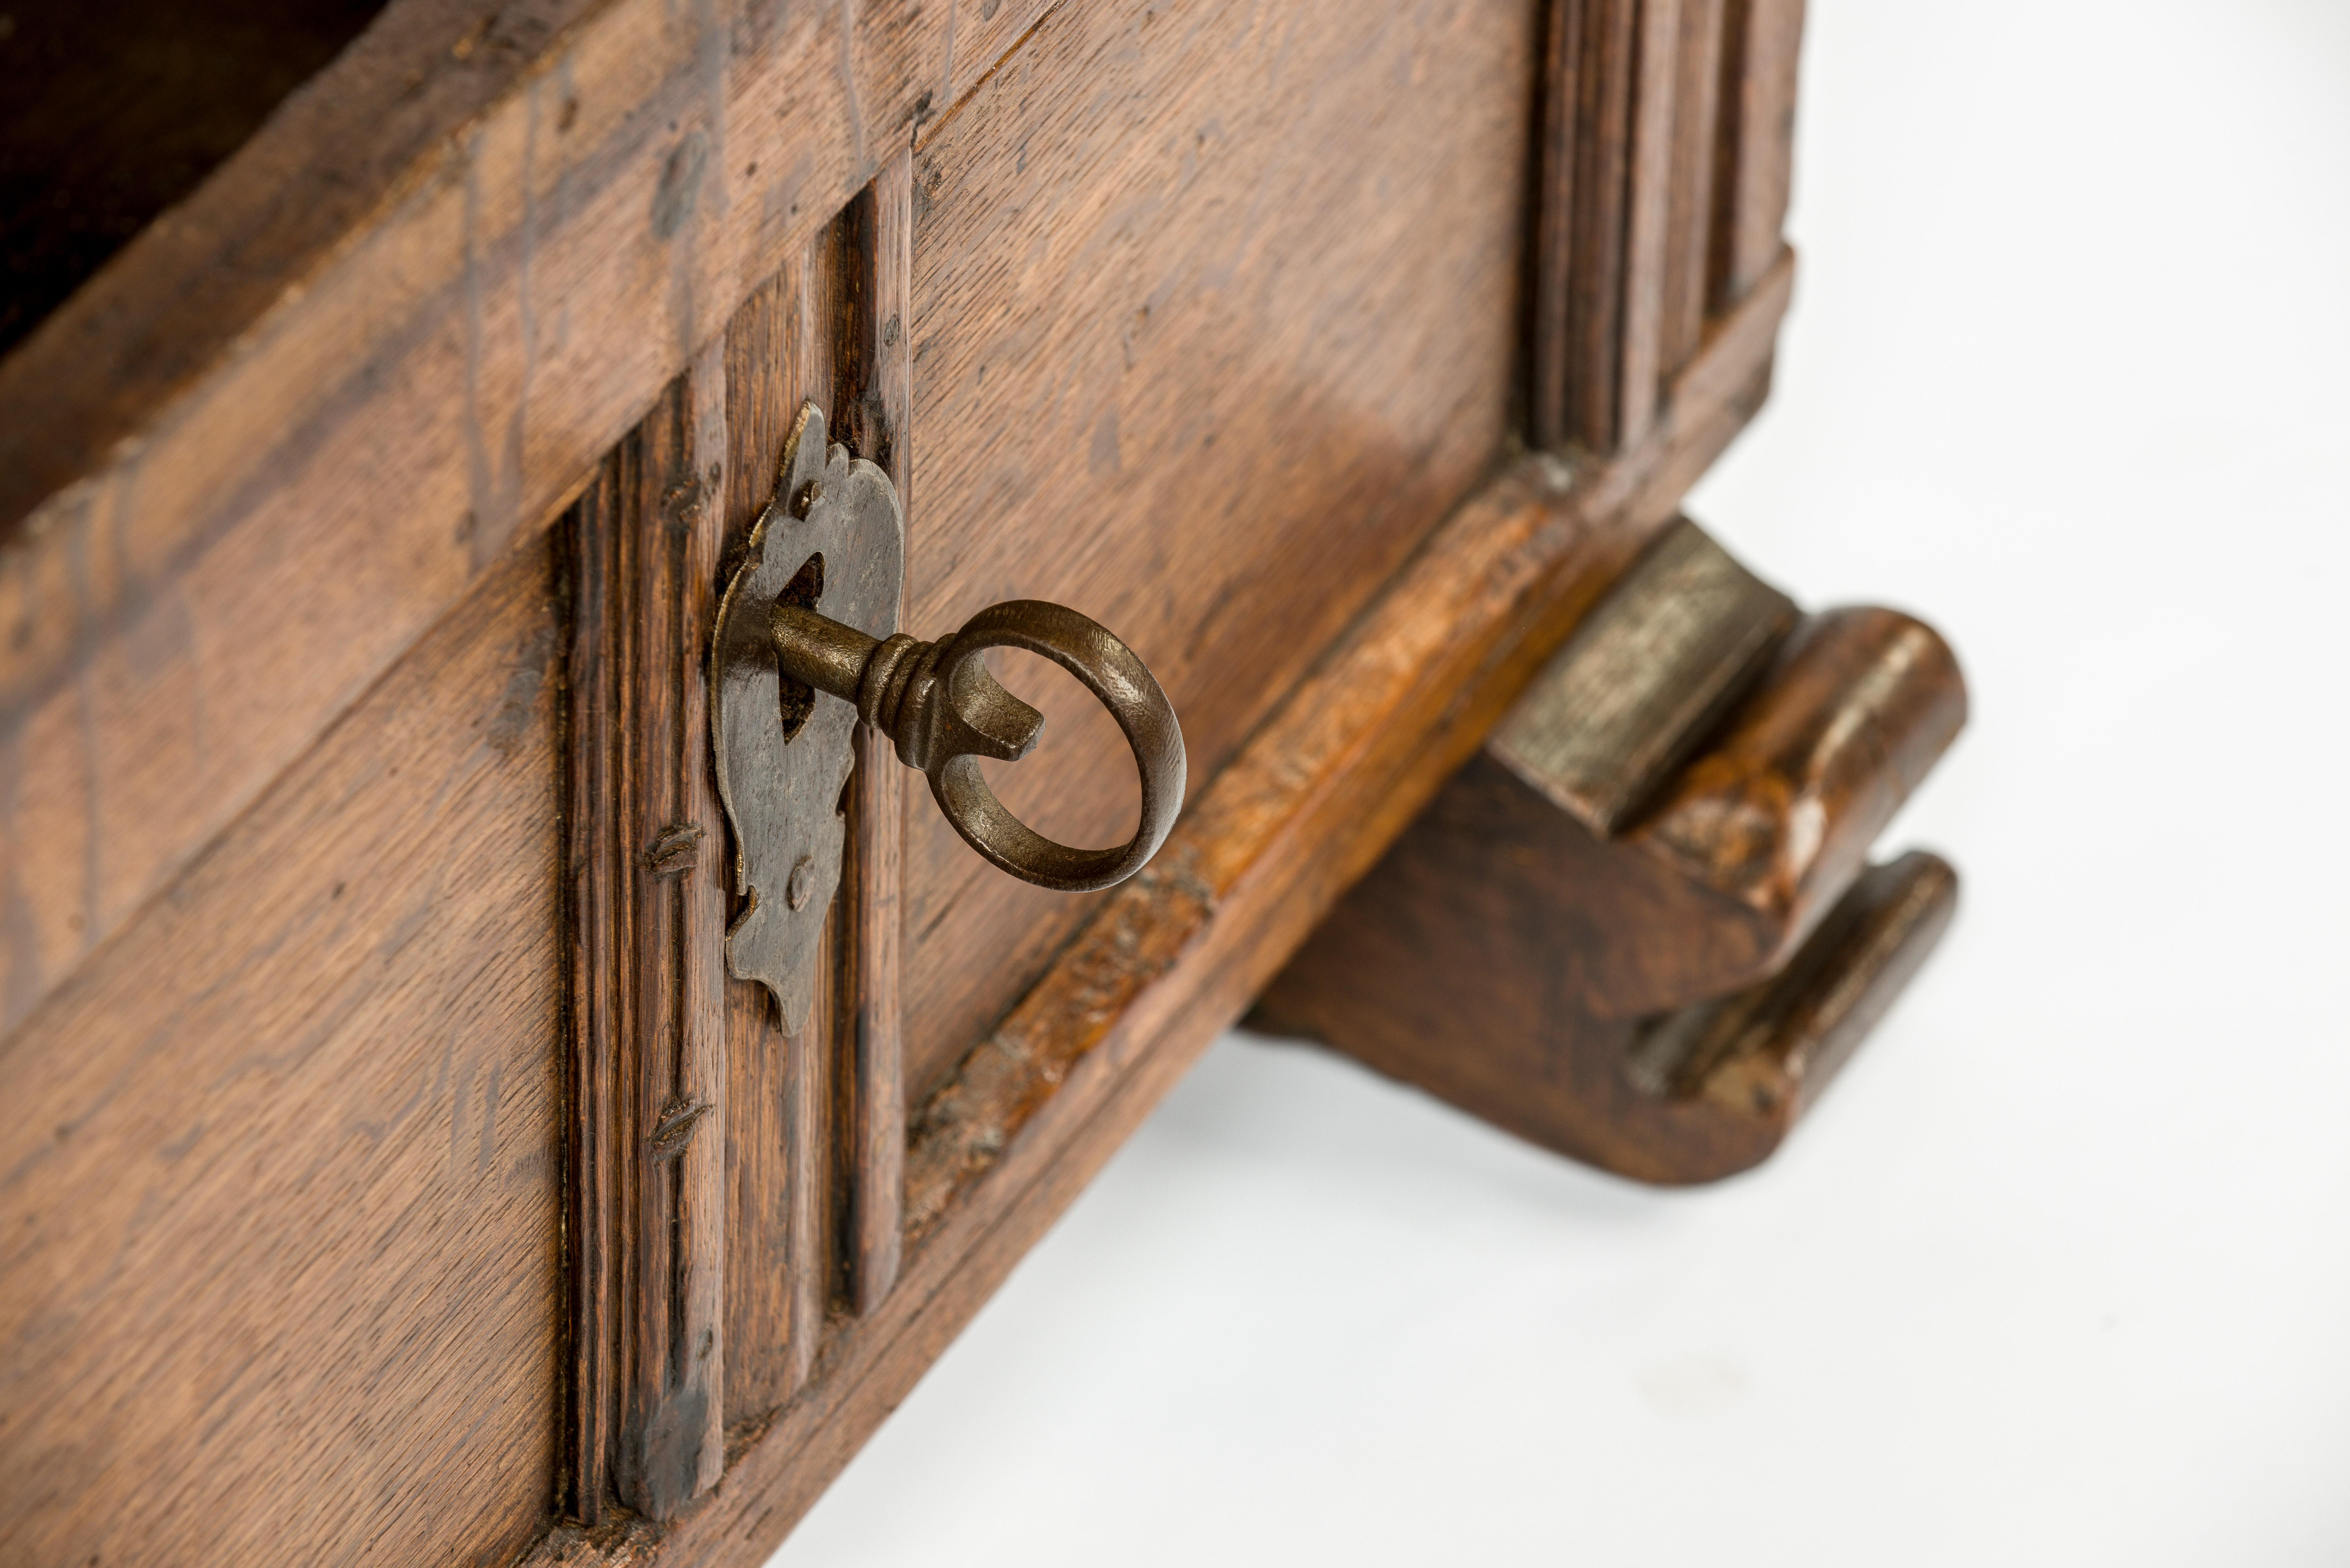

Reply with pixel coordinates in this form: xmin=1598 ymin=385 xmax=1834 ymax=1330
xmin=710 ymin=404 xmax=905 ymax=1034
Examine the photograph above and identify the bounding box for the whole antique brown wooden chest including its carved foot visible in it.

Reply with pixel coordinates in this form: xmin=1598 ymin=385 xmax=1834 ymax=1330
xmin=0 ymin=0 xmax=1962 ymax=1563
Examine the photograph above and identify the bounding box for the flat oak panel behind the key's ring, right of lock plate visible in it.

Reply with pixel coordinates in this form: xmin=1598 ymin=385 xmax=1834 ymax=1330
xmin=905 ymin=0 xmax=1537 ymax=1105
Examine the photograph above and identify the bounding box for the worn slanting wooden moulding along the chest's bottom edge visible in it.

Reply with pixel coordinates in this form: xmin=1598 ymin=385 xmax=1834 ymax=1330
xmin=524 ymin=242 xmax=1793 ymax=1568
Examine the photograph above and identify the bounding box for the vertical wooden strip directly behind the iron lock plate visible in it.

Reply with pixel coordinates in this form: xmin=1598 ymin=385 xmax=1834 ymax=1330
xmin=724 ymin=153 xmax=912 ymax=1422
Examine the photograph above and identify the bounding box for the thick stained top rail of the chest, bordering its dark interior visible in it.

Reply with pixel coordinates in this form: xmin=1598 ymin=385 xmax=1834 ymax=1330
xmin=0 ymin=0 xmax=1036 ymax=1048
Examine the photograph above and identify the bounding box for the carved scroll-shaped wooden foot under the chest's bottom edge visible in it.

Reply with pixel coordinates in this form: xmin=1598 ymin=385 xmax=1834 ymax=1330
xmin=1250 ymin=520 xmax=1967 ymax=1182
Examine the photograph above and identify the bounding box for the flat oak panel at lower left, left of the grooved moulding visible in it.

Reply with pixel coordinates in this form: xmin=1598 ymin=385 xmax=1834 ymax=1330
xmin=0 ymin=548 xmax=564 ymax=1563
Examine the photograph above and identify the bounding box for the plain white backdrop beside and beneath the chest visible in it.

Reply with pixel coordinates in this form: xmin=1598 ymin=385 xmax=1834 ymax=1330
xmin=776 ymin=0 xmax=2350 ymax=1568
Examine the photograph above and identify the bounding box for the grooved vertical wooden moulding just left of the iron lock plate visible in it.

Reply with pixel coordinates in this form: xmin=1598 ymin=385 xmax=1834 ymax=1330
xmin=566 ymin=360 xmax=726 ymax=1519
